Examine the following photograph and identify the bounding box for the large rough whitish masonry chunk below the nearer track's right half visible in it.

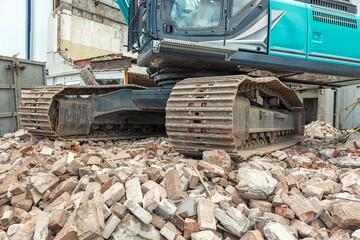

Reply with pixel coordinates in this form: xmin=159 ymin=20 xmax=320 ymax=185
xmin=236 ymin=168 xmax=277 ymax=200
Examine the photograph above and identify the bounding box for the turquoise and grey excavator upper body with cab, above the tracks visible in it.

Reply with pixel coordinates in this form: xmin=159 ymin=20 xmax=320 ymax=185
xmin=128 ymin=0 xmax=360 ymax=81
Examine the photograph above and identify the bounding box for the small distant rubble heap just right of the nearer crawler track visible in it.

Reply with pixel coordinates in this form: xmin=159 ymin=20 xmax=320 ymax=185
xmin=304 ymin=121 xmax=342 ymax=141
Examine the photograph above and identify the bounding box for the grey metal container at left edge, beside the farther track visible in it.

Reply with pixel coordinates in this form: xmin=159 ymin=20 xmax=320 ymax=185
xmin=0 ymin=56 xmax=46 ymax=136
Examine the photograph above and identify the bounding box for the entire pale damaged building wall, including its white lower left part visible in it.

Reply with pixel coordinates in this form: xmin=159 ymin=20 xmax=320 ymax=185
xmin=48 ymin=0 xmax=148 ymax=85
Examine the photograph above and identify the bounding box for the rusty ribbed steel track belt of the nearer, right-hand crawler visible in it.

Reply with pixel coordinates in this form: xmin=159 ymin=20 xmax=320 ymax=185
xmin=166 ymin=76 xmax=302 ymax=158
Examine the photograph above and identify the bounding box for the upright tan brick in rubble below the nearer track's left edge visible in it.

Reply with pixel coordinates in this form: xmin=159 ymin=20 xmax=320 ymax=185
xmin=165 ymin=169 xmax=183 ymax=200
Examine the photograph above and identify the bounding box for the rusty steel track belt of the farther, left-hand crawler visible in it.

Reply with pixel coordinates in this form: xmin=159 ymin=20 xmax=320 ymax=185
xmin=19 ymin=85 xmax=165 ymax=141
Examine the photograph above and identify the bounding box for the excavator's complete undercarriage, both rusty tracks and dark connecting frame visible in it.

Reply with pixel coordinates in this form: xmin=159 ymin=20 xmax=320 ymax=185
xmin=19 ymin=75 xmax=304 ymax=159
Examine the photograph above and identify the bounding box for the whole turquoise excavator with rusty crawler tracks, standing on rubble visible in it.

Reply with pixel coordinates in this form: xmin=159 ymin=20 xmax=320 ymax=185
xmin=19 ymin=0 xmax=360 ymax=159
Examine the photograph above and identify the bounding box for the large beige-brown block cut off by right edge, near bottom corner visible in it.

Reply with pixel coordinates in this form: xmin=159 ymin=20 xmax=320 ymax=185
xmin=331 ymin=201 xmax=360 ymax=230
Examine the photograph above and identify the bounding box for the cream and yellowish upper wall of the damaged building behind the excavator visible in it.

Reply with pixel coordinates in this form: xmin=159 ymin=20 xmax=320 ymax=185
xmin=57 ymin=0 xmax=127 ymax=59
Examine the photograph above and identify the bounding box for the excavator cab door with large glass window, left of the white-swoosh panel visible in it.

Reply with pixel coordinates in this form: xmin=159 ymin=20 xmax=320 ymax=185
xmin=157 ymin=0 xmax=226 ymax=45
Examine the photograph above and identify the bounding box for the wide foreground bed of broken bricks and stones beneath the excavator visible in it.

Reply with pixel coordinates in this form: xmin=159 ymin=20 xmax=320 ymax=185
xmin=0 ymin=130 xmax=360 ymax=240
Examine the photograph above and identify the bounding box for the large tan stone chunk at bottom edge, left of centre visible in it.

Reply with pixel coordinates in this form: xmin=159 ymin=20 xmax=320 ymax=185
xmin=76 ymin=199 xmax=105 ymax=239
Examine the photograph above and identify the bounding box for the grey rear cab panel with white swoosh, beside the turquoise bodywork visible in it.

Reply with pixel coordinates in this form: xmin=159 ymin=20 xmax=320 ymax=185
xmin=225 ymin=0 xmax=269 ymax=53
